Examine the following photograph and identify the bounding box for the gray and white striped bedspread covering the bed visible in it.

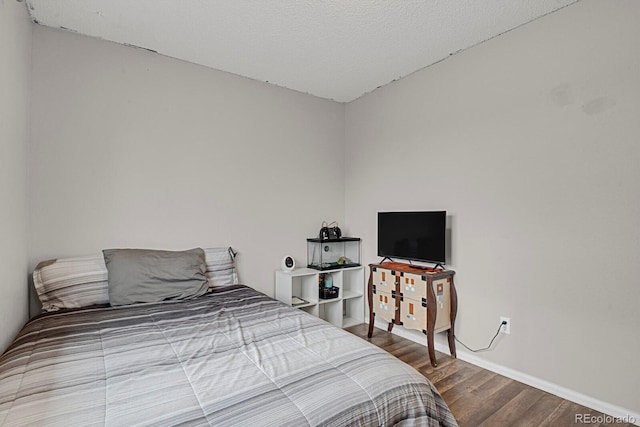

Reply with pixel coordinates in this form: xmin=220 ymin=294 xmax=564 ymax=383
xmin=0 ymin=285 xmax=456 ymax=426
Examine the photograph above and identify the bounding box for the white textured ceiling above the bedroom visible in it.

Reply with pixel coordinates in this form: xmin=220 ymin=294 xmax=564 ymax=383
xmin=26 ymin=0 xmax=577 ymax=102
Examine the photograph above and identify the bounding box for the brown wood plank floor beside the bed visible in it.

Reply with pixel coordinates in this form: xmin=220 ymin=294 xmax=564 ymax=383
xmin=346 ymin=324 xmax=631 ymax=427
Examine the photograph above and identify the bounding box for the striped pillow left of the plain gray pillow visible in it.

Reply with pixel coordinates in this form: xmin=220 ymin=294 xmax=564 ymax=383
xmin=33 ymin=255 xmax=109 ymax=311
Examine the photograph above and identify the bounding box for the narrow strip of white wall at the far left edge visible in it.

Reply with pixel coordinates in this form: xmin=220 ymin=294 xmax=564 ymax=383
xmin=0 ymin=1 xmax=32 ymax=353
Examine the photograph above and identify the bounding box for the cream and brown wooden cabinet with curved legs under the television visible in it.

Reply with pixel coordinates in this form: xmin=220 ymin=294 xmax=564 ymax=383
xmin=367 ymin=262 xmax=458 ymax=366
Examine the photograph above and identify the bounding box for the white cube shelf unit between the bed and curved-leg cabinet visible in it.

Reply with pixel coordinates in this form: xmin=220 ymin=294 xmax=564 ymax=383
xmin=276 ymin=266 xmax=365 ymax=328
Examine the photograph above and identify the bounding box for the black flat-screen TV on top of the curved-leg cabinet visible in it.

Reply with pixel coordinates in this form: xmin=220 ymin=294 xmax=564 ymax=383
xmin=378 ymin=211 xmax=447 ymax=264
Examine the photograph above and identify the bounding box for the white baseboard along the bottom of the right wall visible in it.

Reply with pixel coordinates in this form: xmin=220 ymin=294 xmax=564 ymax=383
xmin=375 ymin=321 xmax=640 ymax=426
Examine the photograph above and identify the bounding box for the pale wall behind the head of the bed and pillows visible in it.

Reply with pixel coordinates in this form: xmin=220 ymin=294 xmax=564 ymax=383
xmin=29 ymin=26 xmax=344 ymax=306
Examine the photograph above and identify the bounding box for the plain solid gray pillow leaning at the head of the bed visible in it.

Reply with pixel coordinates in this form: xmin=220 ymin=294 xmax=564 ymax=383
xmin=102 ymin=248 xmax=209 ymax=306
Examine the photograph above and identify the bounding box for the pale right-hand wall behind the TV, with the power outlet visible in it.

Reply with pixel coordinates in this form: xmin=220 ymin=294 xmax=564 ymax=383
xmin=345 ymin=0 xmax=640 ymax=413
